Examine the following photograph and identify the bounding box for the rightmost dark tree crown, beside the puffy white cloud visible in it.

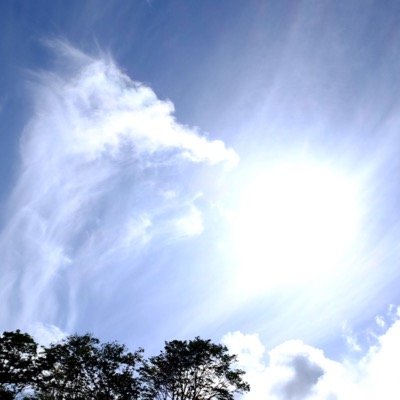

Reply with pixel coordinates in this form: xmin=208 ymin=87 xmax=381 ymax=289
xmin=141 ymin=337 xmax=250 ymax=400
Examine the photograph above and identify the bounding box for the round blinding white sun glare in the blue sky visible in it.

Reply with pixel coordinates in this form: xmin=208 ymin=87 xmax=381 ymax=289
xmin=233 ymin=163 xmax=359 ymax=291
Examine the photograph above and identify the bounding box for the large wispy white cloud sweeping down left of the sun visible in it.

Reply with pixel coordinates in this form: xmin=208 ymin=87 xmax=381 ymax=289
xmin=0 ymin=42 xmax=237 ymax=330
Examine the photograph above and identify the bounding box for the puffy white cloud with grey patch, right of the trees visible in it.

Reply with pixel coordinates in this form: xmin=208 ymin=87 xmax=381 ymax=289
xmin=223 ymin=310 xmax=400 ymax=400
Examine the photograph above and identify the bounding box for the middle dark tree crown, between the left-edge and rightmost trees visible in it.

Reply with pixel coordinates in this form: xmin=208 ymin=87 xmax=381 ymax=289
xmin=36 ymin=334 xmax=141 ymax=400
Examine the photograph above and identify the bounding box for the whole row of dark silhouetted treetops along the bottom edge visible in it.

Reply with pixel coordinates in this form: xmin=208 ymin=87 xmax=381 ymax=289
xmin=0 ymin=330 xmax=250 ymax=400
